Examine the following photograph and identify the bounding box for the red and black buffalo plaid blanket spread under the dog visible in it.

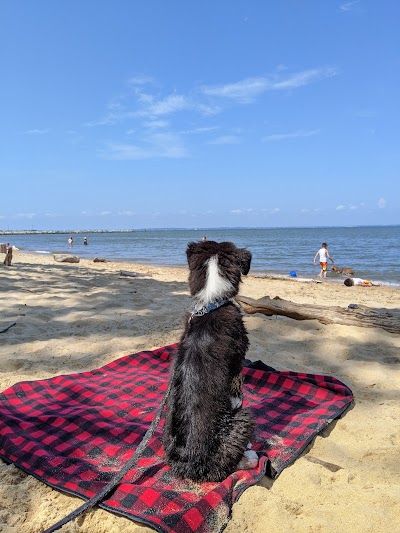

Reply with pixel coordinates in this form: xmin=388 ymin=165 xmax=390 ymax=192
xmin=0 ymin=344 xmax=352 ymax=533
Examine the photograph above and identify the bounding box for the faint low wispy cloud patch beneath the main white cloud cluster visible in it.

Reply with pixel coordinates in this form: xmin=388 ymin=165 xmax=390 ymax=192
xmin=99 ymin=133 xmax=187 ymax=160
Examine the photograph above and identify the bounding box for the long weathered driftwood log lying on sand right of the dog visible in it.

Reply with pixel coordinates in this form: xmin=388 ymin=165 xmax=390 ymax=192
xmin=236 ymin=296 xmax=400 ymax=333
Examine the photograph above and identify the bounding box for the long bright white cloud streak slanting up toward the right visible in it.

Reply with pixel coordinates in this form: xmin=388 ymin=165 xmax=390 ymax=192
xmin=201 ymin=67 xmax=337 ymax=103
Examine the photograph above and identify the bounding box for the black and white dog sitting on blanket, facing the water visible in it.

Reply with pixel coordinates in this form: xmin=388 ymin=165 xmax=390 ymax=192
xmin=163 ymin=241 xmax=258 ymax=481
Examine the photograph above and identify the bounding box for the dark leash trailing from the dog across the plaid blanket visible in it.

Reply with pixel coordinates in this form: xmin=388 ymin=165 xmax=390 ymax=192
xmin=43 ymin=380 xmax=171 ymax=533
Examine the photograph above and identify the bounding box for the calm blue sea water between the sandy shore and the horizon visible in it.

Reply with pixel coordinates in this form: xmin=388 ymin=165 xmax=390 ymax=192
xmin=0 ymin=226 xmax=400 ymax=286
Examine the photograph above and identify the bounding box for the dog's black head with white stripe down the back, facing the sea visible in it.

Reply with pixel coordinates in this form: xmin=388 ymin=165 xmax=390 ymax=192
xmin=186 ymin=241 xmax=251 ymax=305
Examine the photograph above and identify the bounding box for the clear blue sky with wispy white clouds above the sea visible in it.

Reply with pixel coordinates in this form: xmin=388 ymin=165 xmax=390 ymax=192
xmin=0 ymin=0 xmax=400 ymax=230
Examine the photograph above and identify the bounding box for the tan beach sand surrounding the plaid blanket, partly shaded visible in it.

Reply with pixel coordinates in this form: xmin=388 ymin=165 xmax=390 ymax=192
xmin=0 ymin=252 xmax=400 ymax=533
